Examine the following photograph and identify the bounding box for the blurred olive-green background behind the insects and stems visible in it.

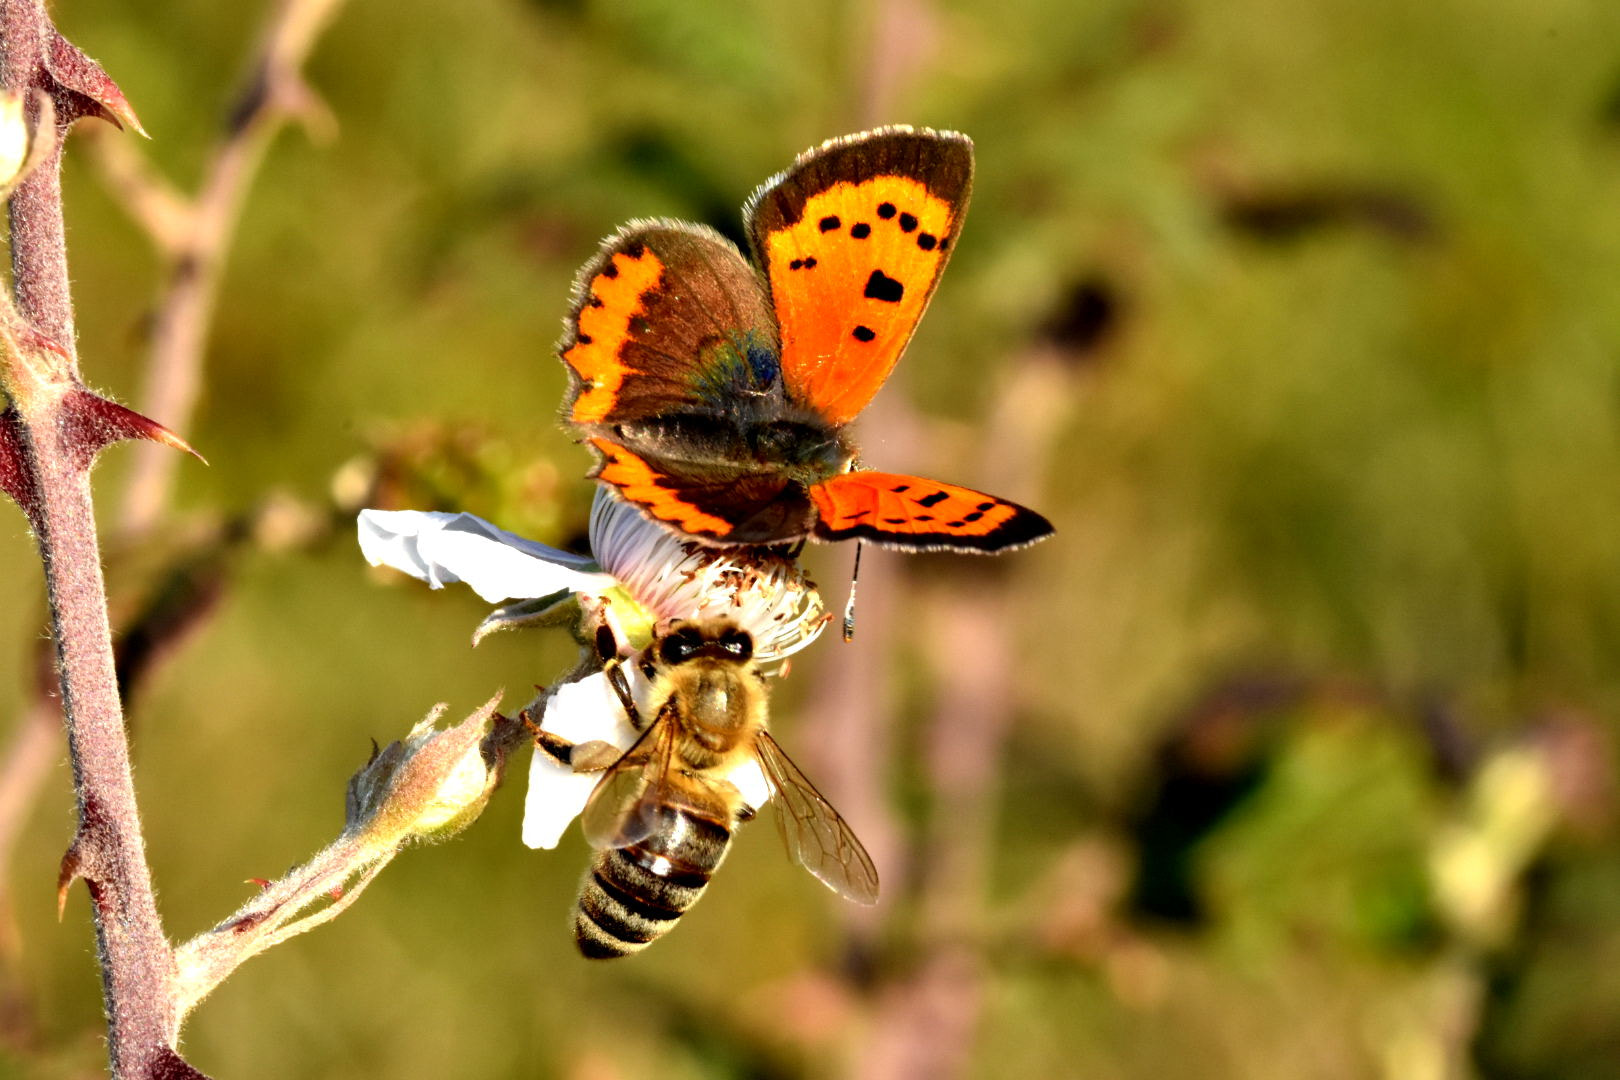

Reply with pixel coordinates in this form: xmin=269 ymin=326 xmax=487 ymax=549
xmin=0 ymin=0 xmax=1620 ymax=1080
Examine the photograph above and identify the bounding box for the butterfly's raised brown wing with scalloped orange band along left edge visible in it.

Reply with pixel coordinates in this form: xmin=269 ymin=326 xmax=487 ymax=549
xmin=557 ymin=220 xmax=779 ymax=434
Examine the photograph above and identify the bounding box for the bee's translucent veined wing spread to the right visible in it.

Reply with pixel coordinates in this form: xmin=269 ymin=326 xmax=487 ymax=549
xmin=755 ymin=732 xmax=878 ymax=904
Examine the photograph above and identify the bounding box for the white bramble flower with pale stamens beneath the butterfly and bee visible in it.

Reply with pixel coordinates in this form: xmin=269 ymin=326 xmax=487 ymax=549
xmin=349 ymin=487 xmax=828 ymax=847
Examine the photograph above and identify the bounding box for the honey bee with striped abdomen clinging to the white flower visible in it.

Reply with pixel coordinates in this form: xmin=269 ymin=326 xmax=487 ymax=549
xmin=541 ymin=619 xmax=878 ymax=960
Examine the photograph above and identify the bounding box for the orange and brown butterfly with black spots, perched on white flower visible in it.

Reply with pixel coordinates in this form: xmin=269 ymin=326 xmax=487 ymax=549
xmin=557 ymin=126 xmax=1051 ymax=552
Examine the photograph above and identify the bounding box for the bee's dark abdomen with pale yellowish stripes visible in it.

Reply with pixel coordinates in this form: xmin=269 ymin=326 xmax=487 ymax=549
xmin=573 ymin=806 xmax=731 ymax=960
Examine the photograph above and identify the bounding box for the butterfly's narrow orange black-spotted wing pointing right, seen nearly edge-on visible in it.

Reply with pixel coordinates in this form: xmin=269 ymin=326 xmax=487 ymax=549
xmin=810 ymin=470 xmax=1051 ymax=552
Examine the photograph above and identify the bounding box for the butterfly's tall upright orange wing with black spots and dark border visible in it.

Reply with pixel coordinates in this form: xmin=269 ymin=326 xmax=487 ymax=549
xmin=744 ymin=128 xmax=974 ymax=426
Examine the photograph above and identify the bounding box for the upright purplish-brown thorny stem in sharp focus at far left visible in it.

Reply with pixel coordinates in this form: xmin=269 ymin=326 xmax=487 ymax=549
xmin=0 ymin=0 xmax=186 ymax=1077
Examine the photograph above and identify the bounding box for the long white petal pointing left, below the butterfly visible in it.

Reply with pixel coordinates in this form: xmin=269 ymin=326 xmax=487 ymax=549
xmin=358 ymin=510 xmax=614 ymax=602
